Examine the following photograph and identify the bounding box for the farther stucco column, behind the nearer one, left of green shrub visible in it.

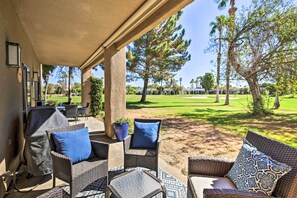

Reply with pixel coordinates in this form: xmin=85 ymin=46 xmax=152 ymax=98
xmin=81 ymin=68 xmax=92 ymax=106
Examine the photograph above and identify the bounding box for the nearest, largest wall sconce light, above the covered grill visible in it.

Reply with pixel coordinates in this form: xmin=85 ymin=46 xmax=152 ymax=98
xmin=6 ymin=42 xmax=21 ymax=67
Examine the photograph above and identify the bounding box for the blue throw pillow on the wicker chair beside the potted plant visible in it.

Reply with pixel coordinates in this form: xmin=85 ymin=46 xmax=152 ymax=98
xmin=132 ymin=122 xmax=160 ymax=148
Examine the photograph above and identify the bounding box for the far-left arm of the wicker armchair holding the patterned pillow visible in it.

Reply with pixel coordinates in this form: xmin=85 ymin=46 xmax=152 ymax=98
xmin=188 ymin=157 xmax=234 ymax=177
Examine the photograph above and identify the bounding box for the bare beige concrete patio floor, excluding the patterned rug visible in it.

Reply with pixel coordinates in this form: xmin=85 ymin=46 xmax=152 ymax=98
xmin=5 ymin=117 xmax=187 ymax=198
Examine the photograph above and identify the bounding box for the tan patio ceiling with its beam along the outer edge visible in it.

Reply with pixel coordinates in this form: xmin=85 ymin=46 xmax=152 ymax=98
xmin=11 ymin=0 xmax=192 ymax=68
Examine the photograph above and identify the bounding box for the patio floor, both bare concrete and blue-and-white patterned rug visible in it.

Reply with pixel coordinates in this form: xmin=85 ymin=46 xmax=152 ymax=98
xmin=6 ymin=117 xmax=187 ymax=198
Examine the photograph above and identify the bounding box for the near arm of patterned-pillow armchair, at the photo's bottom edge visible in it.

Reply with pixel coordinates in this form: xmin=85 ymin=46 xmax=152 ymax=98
xmin=203 ymin=189 xmax=272 ymax=198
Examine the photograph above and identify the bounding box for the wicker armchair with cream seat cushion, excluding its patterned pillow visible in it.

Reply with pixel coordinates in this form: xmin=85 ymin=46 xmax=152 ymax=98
xmin=188 ymin=131 xmax=297 ymax=198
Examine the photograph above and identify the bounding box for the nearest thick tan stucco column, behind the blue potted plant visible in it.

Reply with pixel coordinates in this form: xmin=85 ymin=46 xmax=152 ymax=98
xmin=104 ymin=45 xmax=126 ymax=137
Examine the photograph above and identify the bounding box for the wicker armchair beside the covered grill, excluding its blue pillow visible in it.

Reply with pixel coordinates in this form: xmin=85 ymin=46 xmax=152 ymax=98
xmin=47 ymin=124 xmax=109 ymax=197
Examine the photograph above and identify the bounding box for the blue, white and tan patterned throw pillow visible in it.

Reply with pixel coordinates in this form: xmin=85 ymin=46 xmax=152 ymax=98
xmin=226 ymin=139 xmax=292 ymax=195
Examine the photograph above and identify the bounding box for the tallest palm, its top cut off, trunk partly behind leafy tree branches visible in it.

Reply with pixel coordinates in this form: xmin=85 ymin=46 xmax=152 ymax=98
xmin=215 ymin=0 xmax=237 ymax=105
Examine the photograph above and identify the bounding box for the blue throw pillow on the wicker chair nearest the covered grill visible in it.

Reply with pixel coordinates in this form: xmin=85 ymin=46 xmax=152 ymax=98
xmin=52 ymin=128 xmax=94 ymax=164
